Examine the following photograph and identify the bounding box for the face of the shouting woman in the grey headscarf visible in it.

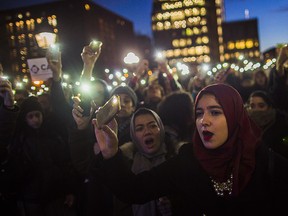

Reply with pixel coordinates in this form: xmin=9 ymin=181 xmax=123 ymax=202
xmin=134 ymin=114 xmax=161 ymax=154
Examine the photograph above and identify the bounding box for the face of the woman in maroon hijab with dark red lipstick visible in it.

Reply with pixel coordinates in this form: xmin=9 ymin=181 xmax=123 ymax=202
xmin=196 ymin=94 xmax=228 ymax=149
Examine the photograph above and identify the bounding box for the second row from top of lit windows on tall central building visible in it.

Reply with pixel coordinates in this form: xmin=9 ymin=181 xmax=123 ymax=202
xmin=152 ymin=8 xmax=207 ymax=21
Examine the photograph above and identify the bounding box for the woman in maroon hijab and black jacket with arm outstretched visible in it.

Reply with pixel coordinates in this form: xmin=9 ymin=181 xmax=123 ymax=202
xmin=94 ymin=84 xmax=288 ymax=216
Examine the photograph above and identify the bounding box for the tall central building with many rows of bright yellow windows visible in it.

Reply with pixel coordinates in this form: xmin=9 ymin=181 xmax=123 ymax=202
xmin=152 ymin=0 xmax=224 ymax=64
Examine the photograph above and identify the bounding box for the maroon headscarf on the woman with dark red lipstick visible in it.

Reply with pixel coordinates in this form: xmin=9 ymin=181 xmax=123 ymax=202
xmin=193 ymin=84 xmax=261 ymax=196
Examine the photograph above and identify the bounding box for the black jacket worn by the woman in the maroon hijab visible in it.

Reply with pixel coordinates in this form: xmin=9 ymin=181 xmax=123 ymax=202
xmin=92 ymin=144 xmax=288 ymax=215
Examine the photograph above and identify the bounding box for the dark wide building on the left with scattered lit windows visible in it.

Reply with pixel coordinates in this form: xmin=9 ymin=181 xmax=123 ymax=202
xmin=0 ymin=0 xmax=134 ymax=80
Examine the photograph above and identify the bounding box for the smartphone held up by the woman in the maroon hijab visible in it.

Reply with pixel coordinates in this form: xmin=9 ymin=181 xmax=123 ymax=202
xmin=96 ymin=95 xmax=121 ymax=128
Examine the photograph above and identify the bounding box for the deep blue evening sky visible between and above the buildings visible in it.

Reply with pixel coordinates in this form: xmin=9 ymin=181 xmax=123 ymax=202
xmin=0 ymin=0 xmax=288 ymax=51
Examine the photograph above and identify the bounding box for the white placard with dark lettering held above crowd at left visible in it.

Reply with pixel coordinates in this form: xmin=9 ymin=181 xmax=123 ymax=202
xmin=27 ymin=58 xmax=53 ymax=81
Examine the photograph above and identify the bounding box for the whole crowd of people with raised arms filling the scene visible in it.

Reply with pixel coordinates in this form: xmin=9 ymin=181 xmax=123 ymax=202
xmin=0 ymin=44 xmax=288 ymax=216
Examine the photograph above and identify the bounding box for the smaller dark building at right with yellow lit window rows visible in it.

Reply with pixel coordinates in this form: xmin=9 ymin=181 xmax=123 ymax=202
xmin=223 ymin=19 xmax=261 ymax=62
